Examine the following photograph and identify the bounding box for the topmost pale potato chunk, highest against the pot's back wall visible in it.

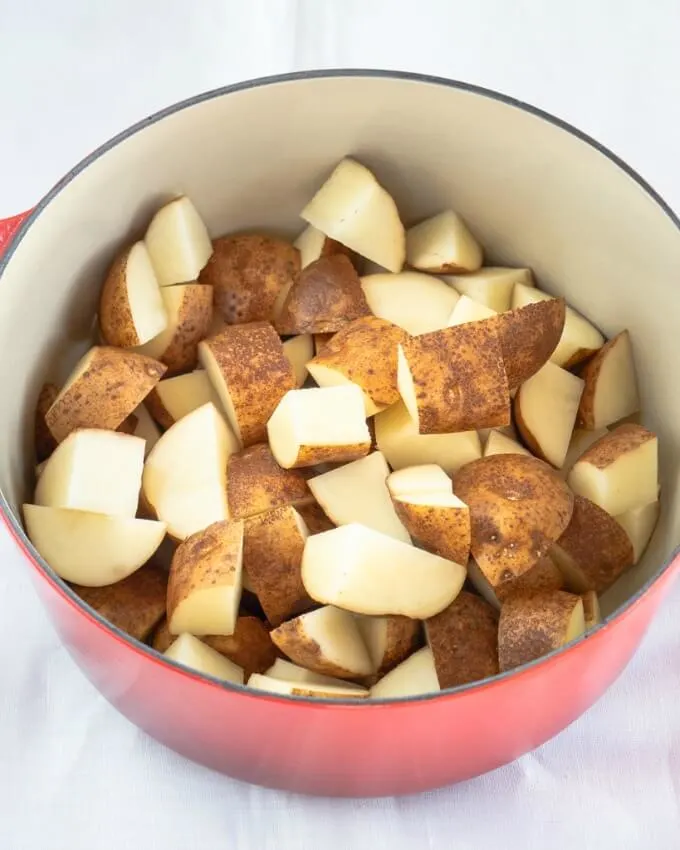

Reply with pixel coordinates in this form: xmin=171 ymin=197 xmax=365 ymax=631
xmin=300 ymin=158 xmax=406 ymax=272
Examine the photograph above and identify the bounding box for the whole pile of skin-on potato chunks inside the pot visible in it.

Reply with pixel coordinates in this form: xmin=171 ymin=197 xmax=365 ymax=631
xmin=24 ymin=159 xmax=659 ymax=699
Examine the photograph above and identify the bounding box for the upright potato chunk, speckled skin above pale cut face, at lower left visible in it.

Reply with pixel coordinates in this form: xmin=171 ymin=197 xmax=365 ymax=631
xmin=168 ymin=520 xmax=243 ymax=635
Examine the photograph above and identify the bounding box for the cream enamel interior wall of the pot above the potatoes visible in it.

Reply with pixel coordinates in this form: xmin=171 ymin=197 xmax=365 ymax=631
xmin=0 ymin=73 xmax=680 ymax=614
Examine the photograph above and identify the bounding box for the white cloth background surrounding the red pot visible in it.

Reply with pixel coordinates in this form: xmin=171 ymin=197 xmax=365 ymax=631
xmin=0 ymin=0 xmax=680 ymax=850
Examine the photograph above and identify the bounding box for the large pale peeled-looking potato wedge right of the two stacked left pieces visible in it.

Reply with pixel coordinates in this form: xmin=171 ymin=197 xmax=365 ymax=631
xmin=142 ymin=404 xmax=238 ymax=540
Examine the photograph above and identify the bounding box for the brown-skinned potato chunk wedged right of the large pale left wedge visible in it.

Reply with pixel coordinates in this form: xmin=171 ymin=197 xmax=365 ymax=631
xmin=227 ymin=443 xmax=314 ymax=519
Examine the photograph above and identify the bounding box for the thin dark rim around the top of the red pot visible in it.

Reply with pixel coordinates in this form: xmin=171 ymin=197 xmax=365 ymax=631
xmin=0 ymin=68 xmax=680 ymax=711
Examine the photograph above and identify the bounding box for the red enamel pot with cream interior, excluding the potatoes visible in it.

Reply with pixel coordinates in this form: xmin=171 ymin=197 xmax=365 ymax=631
xmin=0 ymin=71 xmax=680 ymax=796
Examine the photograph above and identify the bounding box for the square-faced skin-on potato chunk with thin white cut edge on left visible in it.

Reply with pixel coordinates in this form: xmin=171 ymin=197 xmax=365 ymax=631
xmin=397 ymin=322 xmax=510 ymax=434
